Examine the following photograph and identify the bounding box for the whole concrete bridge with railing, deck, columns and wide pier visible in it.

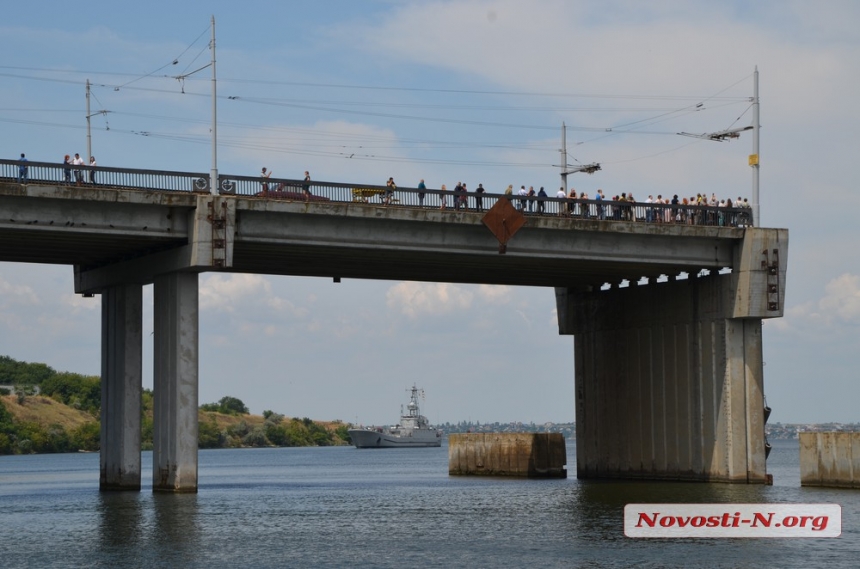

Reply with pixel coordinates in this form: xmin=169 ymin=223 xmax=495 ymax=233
xmin=0 ymin=160 xmax=788 ymax=492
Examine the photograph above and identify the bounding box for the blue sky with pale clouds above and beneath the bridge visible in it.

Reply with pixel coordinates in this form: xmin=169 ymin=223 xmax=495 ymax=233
xmin=0 ymin=0 xmax=860 ymax=424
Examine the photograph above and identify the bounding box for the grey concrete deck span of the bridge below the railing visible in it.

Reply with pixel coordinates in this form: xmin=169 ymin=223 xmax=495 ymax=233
xmin=0 ymin=182 xmax=745 ymax=292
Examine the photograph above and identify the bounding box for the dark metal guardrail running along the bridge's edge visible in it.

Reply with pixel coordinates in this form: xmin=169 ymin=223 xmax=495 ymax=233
xmin=0 ymin=159 xmax=752 ymax=227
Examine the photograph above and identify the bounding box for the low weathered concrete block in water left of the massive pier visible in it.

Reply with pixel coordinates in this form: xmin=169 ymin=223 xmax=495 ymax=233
xmin=448 ymin=433 xmax=567 ymax=478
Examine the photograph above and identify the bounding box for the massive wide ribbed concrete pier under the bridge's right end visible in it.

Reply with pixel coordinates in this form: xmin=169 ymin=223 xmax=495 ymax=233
xmin=556 ymin=274 xmax=767 ymax=483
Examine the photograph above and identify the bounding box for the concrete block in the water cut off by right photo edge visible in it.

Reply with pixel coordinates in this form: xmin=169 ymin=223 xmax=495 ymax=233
xmin=800 ymin=433 xmax=860 ymax=488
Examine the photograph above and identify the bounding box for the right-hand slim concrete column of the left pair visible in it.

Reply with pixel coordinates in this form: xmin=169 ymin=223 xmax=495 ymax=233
xmin=152 ymin=273 xmax=199 ymax=492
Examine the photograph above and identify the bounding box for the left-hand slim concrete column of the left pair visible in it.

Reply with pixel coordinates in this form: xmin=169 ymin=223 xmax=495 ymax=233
xmin=99 ymin=284 xmax=143 ymax=491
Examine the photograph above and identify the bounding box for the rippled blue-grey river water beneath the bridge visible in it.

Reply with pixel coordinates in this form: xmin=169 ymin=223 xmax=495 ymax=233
xmin=0 ymin=441 xmax=860 ymax=569
